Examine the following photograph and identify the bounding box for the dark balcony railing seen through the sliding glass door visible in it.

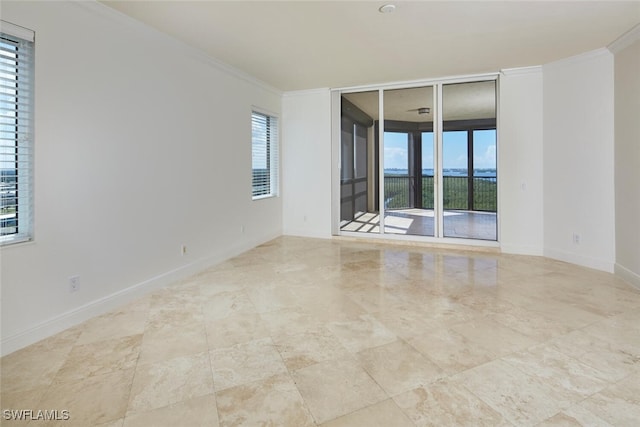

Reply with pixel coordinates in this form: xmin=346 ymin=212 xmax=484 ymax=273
xmin=384 ymin=175 xmax=498 ymax=212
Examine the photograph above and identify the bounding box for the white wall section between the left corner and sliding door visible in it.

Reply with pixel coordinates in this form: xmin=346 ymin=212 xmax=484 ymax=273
xmin=282 ymin=89 xmax=331 ymax=237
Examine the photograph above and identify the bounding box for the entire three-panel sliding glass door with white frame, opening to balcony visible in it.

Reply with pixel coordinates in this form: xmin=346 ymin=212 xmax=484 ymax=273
xmin=340 ymin=79 xmax=498 ymax=241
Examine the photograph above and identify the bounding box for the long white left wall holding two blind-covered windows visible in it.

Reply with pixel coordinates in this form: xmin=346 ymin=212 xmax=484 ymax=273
xmin=0 ymin=1 xmax=280 ymax=354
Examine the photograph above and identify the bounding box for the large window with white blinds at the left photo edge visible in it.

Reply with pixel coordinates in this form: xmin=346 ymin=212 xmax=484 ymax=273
xmin=0 ymin=21 xmax=34 ymax=245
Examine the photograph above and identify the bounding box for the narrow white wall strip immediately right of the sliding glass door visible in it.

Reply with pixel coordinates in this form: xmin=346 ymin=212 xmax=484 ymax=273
xmin=498 ymin=67 xmax=543 ymax=255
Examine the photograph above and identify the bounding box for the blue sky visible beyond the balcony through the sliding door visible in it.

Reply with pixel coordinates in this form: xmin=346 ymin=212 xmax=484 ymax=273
xmin=384 ymin=130 xmax=496 ymax=169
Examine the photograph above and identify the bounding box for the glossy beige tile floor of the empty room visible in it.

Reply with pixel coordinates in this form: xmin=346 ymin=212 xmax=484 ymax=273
xmin=1 ymin=237 xmax=640 ymax=427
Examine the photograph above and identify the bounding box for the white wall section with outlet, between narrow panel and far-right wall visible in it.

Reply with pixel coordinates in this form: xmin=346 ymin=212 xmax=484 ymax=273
xmin=543 ymin=49 xmax=615 ymax=272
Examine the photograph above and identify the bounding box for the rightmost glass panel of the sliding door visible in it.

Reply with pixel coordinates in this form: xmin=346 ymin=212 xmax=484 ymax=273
xmin=442 ymin=81 xmax=497 ymax=240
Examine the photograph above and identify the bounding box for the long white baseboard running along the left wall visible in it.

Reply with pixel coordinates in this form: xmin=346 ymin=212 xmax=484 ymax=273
xmin=0 ymin=234 xmax=279 ymax=356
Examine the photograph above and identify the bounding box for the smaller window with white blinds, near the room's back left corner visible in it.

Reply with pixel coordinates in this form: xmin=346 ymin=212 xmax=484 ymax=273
xmin=251 ymin=111 xmax=278 ymax=199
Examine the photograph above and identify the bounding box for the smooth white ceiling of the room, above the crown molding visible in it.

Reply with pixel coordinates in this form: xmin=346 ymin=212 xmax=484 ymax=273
xmin=102 ymin=0 xmax=640 ymax=91
